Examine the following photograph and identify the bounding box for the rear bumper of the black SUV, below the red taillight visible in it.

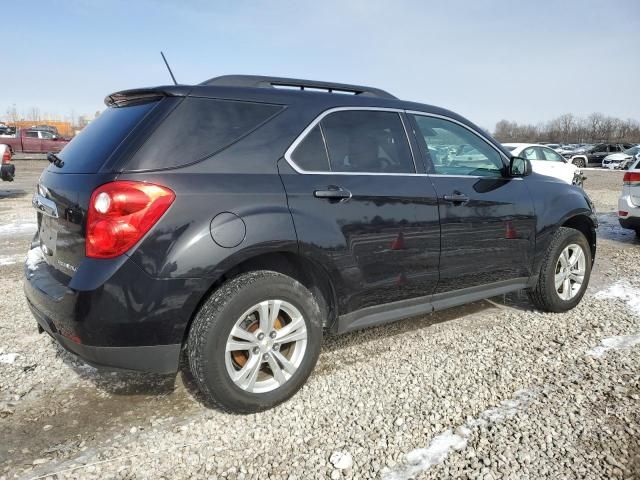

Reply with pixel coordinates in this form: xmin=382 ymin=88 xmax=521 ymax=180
xmin=24 ymin=247 xmax=207 ymax=373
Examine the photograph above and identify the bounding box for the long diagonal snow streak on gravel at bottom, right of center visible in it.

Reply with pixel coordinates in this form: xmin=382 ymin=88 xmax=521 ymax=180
xmin=382 ymin=390 xmax=538 ymax=480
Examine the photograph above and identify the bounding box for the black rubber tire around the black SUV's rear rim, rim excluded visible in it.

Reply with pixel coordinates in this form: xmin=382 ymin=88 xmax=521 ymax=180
xmin=187 ymin=270 xmax=322 ymax=413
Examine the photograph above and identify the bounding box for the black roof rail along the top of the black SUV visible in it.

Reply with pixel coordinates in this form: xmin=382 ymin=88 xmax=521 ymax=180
xmin=200 ymin=75 xmax=397 ymax=99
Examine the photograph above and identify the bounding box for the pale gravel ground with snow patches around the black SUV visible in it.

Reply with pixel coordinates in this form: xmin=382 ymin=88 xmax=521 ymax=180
xmin=0 ymin=161 xmax=640 ymax=480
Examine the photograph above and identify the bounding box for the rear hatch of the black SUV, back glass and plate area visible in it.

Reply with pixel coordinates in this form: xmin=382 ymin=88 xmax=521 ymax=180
xmin=33 ymin=94 xmax=166 ymax=285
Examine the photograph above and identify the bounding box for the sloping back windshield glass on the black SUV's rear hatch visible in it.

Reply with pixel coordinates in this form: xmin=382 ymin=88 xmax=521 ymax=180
xmin=56 ymin=102 xmax=158 ymax=173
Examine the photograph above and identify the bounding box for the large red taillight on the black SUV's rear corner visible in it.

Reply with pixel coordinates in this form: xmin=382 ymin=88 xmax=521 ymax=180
xmin=85 ymin=181 xmax=175 ymax=258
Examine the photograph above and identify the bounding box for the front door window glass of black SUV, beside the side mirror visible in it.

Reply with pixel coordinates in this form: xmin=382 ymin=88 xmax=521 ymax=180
xmin=414 ymin=115 xmax=504 ymax=176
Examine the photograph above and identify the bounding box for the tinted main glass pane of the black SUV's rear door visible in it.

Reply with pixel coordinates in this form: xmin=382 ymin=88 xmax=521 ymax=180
xmin=321 ymin=110 xmax=415 ymax=173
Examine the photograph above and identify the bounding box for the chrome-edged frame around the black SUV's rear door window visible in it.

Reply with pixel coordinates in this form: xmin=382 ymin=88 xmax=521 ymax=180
xmin=284 ymin=107 xmax=424 ymax=177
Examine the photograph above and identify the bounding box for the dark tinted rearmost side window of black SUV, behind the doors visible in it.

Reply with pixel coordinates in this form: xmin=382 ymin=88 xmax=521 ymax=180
xmin=126 ymin=97 xmax=282 ymax=170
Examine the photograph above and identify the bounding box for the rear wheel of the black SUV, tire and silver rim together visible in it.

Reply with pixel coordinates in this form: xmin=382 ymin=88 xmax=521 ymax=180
xmin=187 ymin=271 xmax=322 ymax=413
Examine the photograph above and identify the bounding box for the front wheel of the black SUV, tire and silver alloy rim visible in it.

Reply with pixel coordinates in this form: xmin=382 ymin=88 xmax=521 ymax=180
xmin=528 ymin=227 xmax=592 ymax=312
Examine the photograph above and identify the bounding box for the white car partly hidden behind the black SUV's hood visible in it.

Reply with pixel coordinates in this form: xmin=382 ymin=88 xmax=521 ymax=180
xmin=502 ymin=143 xmax=584 ymax=186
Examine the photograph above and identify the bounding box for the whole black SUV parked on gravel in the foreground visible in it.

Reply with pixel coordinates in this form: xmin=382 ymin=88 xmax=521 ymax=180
xmin=25 ymin=76 xmax=596 ymax=412
